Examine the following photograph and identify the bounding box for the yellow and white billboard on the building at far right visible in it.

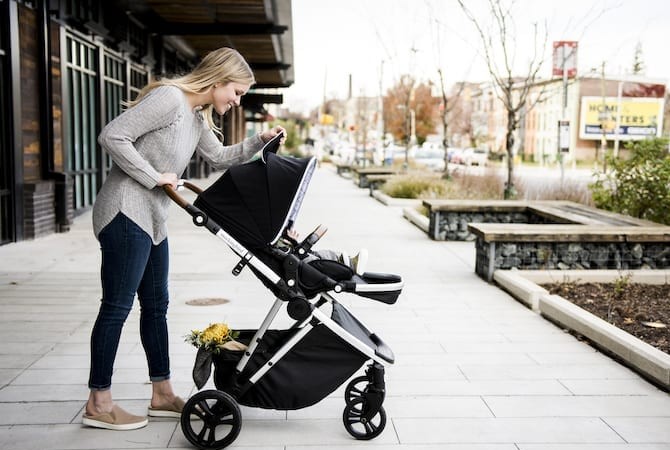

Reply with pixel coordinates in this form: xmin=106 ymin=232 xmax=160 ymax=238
xmin=579 ymin=97 xmax=663 ymax=140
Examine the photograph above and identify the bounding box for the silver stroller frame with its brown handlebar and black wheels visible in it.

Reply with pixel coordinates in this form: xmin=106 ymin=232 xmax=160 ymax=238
xmin=164 ymin=176 xmax=403 ymax=448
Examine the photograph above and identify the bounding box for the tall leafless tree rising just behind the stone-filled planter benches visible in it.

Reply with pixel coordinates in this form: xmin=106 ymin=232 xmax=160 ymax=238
xmin=458 ymin=0 xmax=548 ymax=199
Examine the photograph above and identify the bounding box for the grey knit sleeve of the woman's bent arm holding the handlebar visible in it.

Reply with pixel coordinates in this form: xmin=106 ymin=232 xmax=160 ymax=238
xmin=98 ymin=86 xmax=183 ymax=189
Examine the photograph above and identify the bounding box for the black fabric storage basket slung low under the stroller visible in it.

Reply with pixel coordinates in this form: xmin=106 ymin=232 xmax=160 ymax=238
xmin=214 ymin=305 xmax=376 ymax=410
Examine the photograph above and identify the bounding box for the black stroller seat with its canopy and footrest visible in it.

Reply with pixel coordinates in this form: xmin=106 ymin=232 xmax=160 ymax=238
xmin=193 ymin=144 xmax=402 ymax=304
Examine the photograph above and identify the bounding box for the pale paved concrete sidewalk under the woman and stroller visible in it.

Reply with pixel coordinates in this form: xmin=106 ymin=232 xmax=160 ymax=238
xmin=0 ymin=167 xmax=670 ymax=450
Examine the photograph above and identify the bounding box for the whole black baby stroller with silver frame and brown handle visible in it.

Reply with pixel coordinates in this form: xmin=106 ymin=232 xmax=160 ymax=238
xmin=165 ymin=137 xmax=403 ymax=449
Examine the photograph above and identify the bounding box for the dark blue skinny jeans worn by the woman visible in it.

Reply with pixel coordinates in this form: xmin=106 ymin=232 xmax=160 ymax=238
xmin=88 ymin=213 xmax=170 ymax=390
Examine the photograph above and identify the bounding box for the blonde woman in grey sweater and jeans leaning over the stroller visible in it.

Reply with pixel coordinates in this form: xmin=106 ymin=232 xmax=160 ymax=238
xmin=82 ymin=48 xmax=284 ymax=430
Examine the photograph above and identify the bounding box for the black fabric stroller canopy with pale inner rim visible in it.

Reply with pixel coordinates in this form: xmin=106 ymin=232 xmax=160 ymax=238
xmin=193 ymin=142 xmax=316 ymax=249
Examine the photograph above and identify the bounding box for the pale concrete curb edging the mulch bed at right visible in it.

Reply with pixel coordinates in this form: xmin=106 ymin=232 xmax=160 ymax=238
xmin=493 ymin=270 xmax=670 ymax=390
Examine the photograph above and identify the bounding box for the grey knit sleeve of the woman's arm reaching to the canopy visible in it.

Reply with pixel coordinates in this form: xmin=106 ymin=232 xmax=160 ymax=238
xmin=196 ymin=121 xmax=264 ymax=170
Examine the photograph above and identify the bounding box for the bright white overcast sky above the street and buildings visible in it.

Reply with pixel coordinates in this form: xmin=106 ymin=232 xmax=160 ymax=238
xmin=284 ymin=0 xmax=670 ymax=113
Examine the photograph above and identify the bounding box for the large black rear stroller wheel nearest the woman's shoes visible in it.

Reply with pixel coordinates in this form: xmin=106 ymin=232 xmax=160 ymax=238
xmin=181 ymin=390 xmax=242 ymax=449
